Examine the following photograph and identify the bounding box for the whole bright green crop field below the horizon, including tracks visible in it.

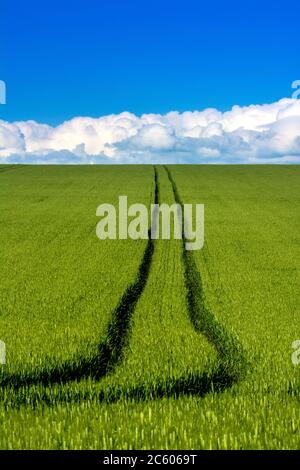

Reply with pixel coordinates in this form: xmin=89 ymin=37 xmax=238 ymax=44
xmin=0 ymin=166 xmax=300 ymax=449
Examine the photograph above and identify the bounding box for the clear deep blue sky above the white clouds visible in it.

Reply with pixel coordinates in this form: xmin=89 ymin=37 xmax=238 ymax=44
xmin=0 ymin=0 xmax=300 ymax=125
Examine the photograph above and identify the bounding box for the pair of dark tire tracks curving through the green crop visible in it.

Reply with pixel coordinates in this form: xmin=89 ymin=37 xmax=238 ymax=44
xmin=0 ymin=163 xmax=247 ymax=407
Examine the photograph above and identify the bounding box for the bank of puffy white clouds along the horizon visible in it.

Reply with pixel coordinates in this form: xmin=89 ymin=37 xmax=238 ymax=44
xmin=0 ymin=98 xmax=300 ymax=164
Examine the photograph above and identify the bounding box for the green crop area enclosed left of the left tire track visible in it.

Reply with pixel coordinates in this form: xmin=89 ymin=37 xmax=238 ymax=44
xmin=0 ymin=167 xmax=153 ymax=372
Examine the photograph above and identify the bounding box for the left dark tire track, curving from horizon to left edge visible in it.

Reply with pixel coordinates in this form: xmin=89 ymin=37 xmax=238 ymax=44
xmin=0 ymin=167 xmax=159 ymax=388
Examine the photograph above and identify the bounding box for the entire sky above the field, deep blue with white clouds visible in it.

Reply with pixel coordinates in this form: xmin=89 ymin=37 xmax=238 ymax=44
xmin=0 ymin=0 xmax=300 ymax=162
